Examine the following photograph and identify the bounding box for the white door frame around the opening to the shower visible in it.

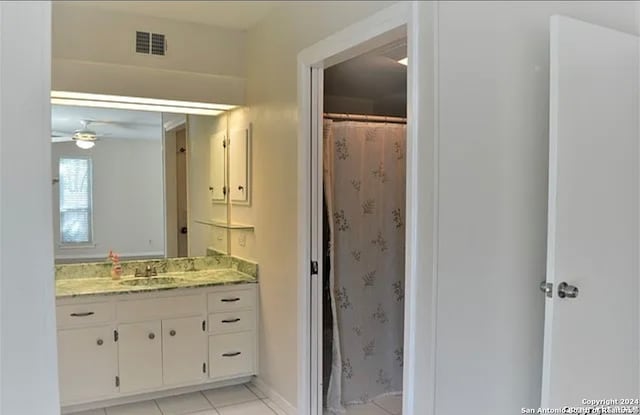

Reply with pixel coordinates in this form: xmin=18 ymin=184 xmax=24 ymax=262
xmin=297 ymin=1 xmax=438 ymax=415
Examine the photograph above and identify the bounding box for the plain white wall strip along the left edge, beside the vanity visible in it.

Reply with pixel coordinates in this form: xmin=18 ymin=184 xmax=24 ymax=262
xmin=0 ymin=1 xmax=60 ymax=415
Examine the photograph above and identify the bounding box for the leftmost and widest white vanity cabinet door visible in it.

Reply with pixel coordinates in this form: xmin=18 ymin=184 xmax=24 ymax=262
xmin=58 ymin=325 xmax=118 ymax=405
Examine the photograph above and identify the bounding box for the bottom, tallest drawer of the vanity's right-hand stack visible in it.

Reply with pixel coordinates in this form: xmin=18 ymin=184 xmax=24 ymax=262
xmin=209 ymin=332 xmax=255 ymax=378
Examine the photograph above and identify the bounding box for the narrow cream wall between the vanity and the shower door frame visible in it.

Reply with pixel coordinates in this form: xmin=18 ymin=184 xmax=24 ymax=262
xmin=247 ymin=1 xmax=393 ymax=405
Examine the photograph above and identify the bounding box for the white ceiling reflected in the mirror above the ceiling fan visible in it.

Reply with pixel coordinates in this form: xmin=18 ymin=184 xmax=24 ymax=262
xmin=51 ymin=105 xmax=162 ymax=140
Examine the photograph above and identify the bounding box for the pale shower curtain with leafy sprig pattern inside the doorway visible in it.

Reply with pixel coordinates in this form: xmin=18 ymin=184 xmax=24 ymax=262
xmin=323 ymin=120 xmax=406 ymax=413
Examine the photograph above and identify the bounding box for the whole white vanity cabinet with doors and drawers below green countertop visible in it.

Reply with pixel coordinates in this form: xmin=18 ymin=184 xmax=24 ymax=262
xmin=57 ymin=284 xmax=257 ymax=407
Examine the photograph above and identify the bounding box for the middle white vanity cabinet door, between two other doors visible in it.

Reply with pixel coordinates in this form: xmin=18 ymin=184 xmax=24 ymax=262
xmin=118 ymin=321 xmax=162 ymax=393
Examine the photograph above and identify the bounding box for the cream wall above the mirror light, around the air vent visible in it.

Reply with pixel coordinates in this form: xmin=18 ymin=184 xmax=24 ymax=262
xmin=52 ymin=2 xmax=246 ymax=104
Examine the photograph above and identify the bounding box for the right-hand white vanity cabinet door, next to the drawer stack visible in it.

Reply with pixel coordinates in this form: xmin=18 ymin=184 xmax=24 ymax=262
xmin=162 ymin=316 xmax=207 ymax=385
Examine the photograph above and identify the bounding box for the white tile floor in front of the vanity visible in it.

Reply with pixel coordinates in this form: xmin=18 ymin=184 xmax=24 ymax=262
xmin=74 ymin=384 xmax=288 ymax=415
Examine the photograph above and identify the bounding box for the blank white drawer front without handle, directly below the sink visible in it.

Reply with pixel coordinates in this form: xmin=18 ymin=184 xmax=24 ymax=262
xmin=118 ymin=294 xmax=205 ymax=322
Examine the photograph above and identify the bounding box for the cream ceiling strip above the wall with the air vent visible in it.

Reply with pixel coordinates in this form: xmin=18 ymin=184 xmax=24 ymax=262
xmin=62 ymin=1 xmax=283 ymax=30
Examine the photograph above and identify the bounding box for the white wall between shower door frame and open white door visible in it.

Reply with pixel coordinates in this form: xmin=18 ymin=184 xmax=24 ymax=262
xmin=432 ymin=1 xmax=638 ymax=415
